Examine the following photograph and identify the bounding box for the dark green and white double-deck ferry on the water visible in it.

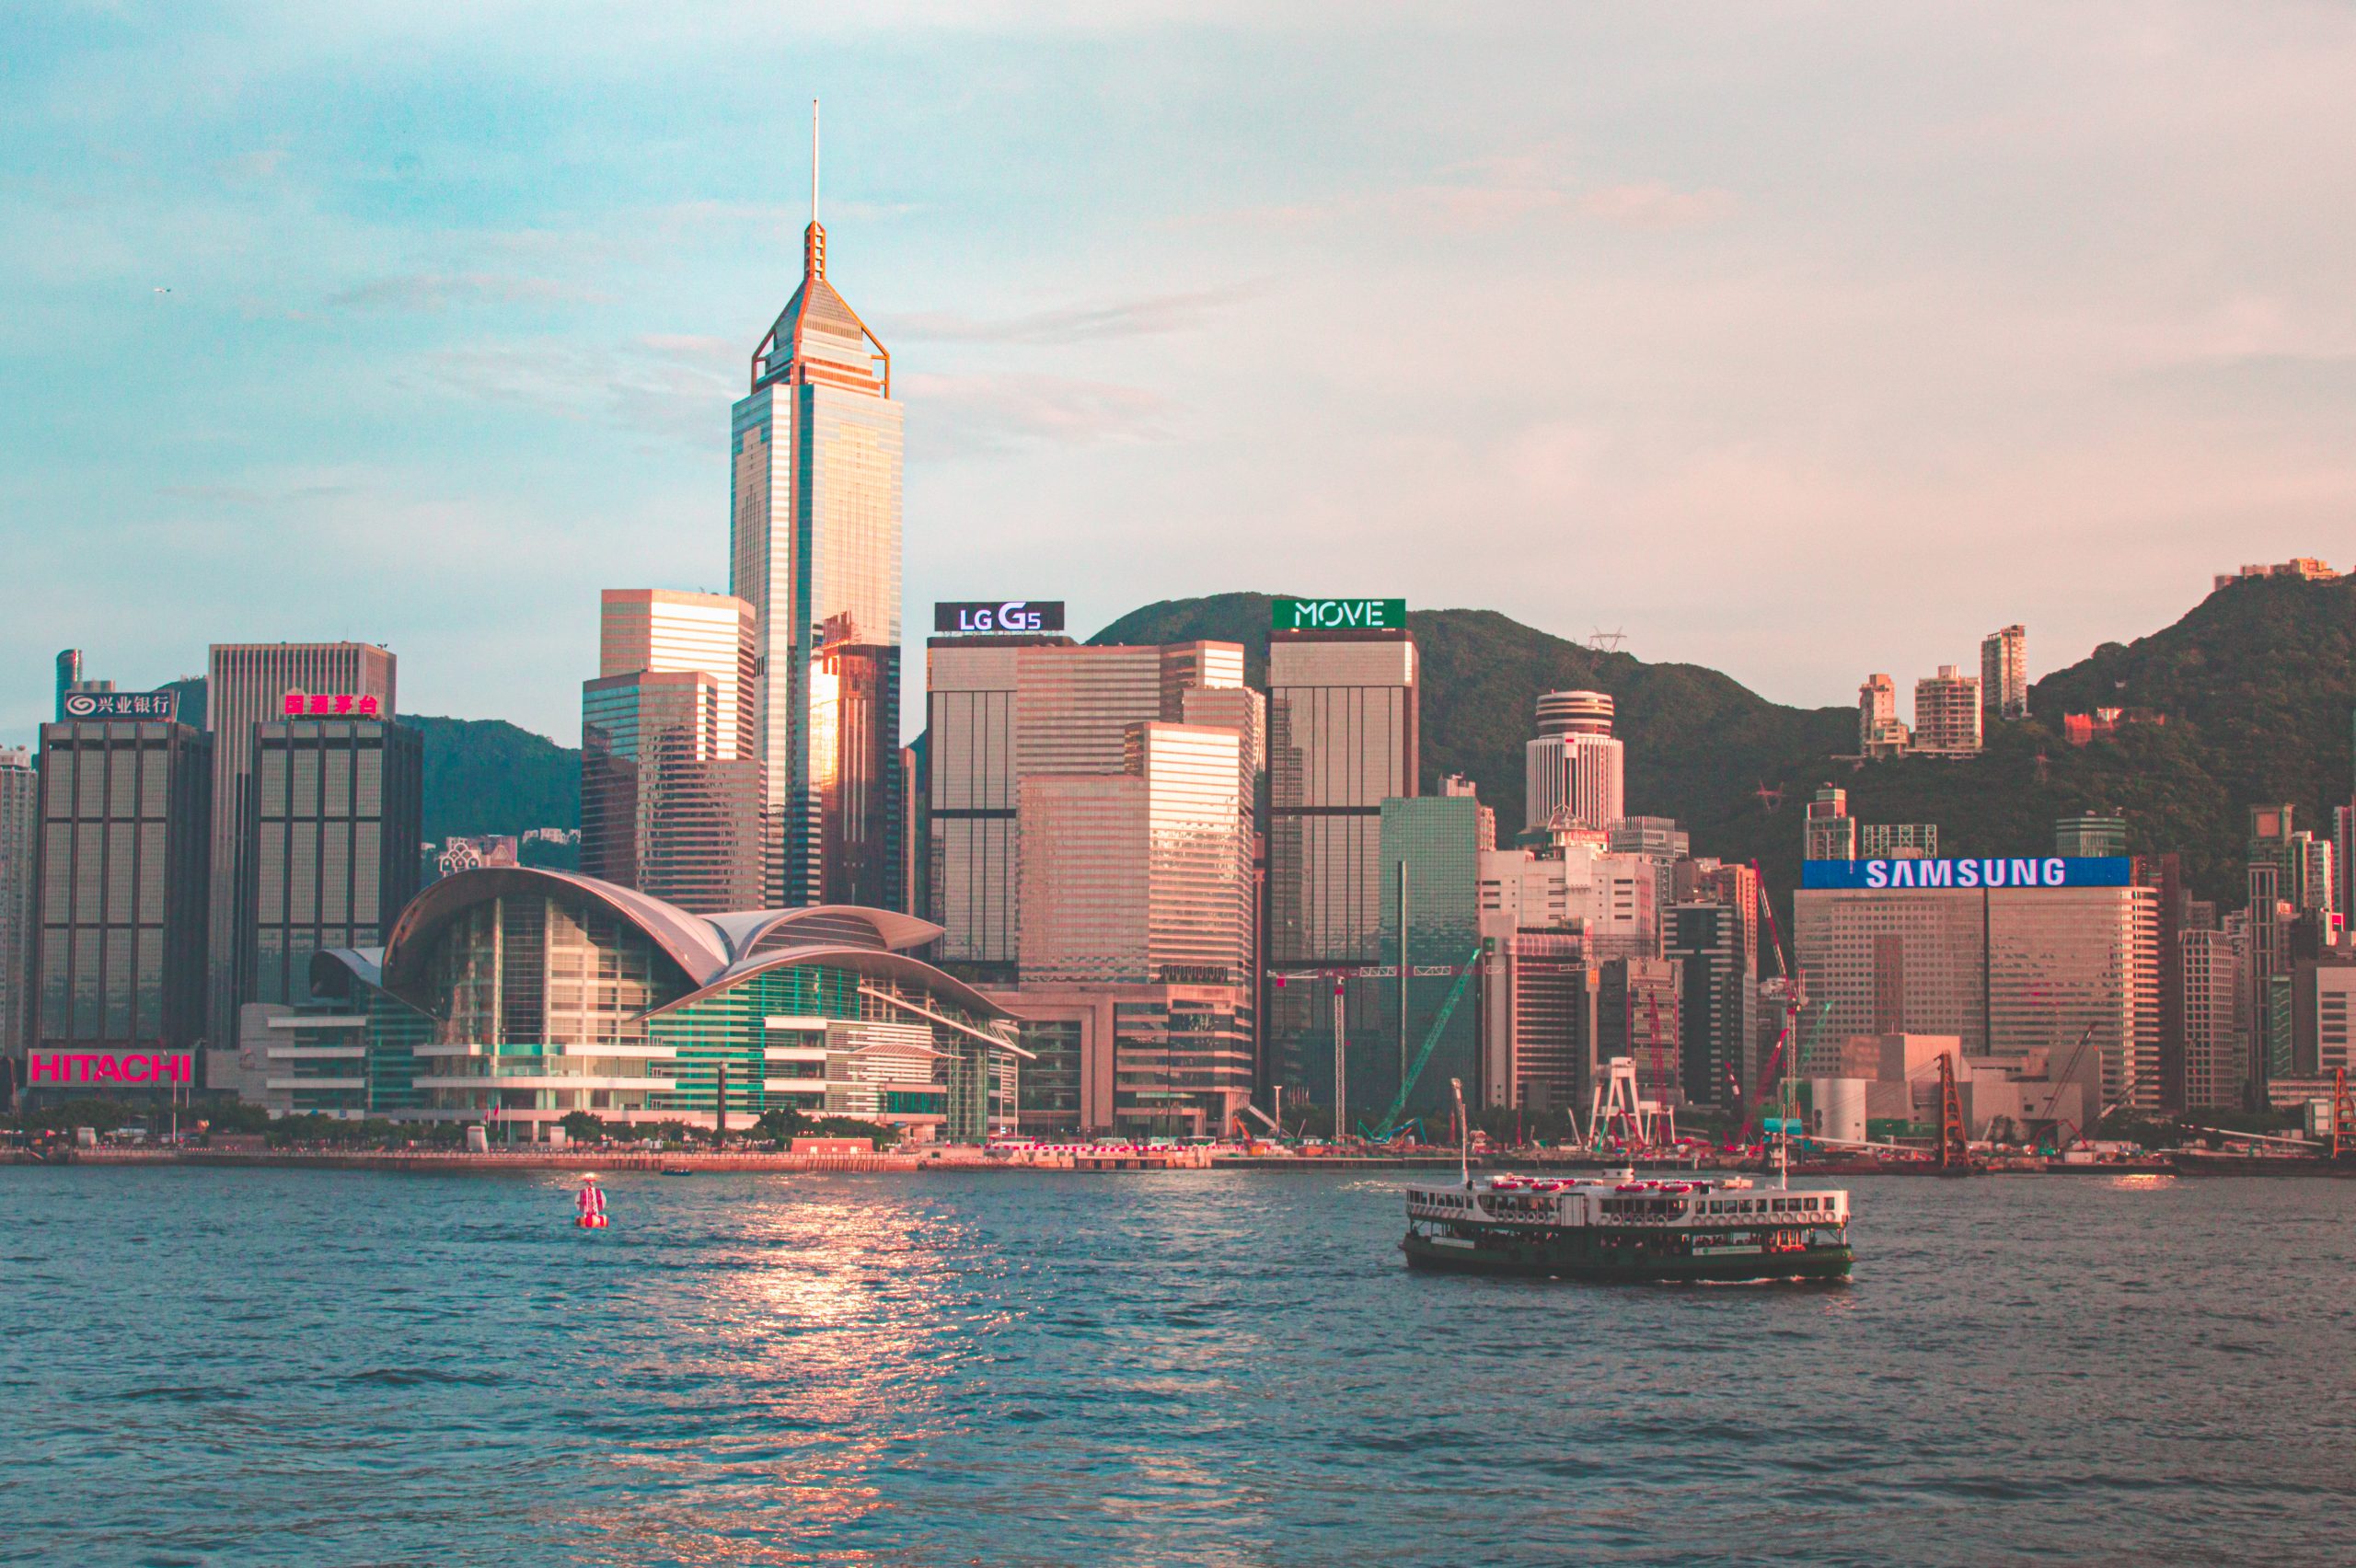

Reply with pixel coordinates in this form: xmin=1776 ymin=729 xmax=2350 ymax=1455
xmin=1400 ymin=1172 xmax=1852 ymax=1283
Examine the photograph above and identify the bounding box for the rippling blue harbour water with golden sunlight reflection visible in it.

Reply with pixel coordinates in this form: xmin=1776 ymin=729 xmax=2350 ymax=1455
xmin=0 ymin=1168 xmax=2356 ymax=1565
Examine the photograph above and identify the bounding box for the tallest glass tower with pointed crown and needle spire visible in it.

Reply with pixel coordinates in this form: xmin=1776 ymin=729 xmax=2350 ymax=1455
xmin=728 ymin=101 xmax=905 ymax=909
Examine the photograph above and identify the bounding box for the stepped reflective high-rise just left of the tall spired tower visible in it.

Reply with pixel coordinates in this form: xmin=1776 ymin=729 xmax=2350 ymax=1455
xmin=582 ymin=589 xmax=768 ymax=914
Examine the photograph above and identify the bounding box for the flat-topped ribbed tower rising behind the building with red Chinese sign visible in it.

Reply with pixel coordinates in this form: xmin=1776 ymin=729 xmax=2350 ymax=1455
xmin=205 ymin=642 xmax=396 ymax=1048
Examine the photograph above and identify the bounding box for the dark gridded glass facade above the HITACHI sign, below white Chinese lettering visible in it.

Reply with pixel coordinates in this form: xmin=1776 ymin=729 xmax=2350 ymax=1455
xmin=33 ymin=721 xmax=212 ymax=1050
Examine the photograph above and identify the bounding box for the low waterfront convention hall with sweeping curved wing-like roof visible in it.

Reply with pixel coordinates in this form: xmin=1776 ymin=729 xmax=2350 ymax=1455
xmin=273 ymin=867 xmax=1022 ymax=1142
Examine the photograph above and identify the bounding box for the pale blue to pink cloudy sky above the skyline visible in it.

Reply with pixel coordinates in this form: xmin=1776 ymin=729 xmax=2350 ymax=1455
xmin=0 ymin=0 xmax=2356 ymax=744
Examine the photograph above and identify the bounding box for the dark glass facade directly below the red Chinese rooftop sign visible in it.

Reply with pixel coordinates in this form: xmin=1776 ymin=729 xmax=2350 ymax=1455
xmin=238 ymin=718 xmax=424 ymax=1003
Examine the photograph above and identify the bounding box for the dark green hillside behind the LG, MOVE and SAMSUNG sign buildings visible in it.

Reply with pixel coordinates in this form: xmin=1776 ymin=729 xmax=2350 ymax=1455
xmin=1093 ymin=579 xmax=2356 ymax=904
